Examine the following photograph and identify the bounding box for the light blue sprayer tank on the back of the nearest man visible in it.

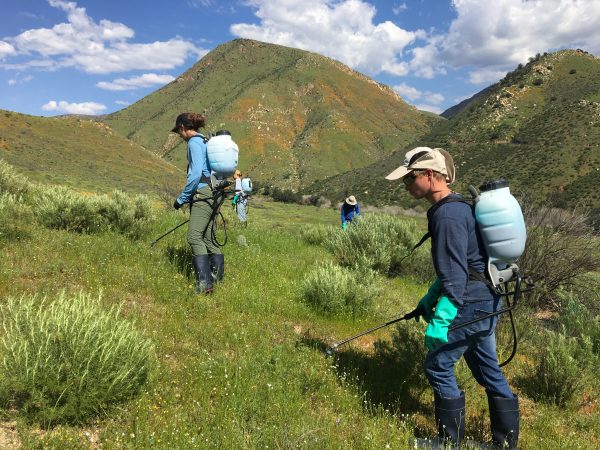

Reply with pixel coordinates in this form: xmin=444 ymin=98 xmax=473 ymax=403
xmin=469 ymin=178 xmax=527 ymax=285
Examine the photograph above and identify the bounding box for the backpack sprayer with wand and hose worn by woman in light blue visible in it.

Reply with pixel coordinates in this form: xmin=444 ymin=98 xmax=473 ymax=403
xmin=150 ymin=130 xmax=252 ymax=247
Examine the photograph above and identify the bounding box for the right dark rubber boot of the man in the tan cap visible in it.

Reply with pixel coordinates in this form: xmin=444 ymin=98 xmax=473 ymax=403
xmin=488 ymin=394 xmax=519 ymax=449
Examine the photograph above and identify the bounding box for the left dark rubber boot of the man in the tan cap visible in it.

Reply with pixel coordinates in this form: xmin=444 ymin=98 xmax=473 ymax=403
xmin=409 ymin=392 xmax=465 ymax=449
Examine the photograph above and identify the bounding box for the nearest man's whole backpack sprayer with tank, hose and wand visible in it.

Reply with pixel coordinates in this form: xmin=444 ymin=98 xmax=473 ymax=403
xmin=325 ymin=178 xmax=535 ymax=366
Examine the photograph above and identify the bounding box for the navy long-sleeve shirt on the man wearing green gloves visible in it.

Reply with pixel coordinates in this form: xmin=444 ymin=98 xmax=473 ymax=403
xmin=427 ymin=194 xmax=487 ymax=305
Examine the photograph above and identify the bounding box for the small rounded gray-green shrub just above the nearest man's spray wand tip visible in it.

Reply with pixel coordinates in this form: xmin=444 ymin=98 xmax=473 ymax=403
xmin=301 ymin=262 xmax=380 ymax=316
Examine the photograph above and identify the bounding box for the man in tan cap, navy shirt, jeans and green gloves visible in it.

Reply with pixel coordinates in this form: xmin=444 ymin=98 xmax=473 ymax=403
xmin=386 ymin=147 xmax=519 ymax=449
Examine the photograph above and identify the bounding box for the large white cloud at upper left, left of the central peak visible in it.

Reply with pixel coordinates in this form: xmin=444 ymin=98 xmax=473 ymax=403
xmin=0 ymin=0 xmax=207 ymax=73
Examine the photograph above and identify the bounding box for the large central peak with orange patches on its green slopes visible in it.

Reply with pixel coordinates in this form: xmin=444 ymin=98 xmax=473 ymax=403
xmin=104 ymin=39 xmax=437 ymax=188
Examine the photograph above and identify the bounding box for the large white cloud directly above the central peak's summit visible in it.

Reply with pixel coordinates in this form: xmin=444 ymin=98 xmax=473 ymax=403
xmin=230 ymin=0 xmax=425 ymax=75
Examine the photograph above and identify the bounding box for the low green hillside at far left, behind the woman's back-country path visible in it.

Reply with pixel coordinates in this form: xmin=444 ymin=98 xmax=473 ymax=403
xmin=0 ymin=110 xmax=179 ymax=193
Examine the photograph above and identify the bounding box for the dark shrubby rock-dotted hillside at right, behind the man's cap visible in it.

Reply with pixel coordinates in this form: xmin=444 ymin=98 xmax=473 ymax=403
xmin=309 ymin=50 xmax=600 ymax=207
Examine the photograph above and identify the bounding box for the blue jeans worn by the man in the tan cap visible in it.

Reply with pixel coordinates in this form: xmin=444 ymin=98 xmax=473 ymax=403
xmin=425 ymin=281 xmax=513 ymax=398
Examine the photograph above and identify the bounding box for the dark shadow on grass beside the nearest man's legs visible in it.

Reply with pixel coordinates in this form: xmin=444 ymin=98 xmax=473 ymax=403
xmin=300 ymin=326 xmax=433 ymax=415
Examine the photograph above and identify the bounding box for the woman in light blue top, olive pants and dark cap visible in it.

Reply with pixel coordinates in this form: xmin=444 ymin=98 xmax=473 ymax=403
xmin=171 ymin=113 xmax=225 ymax=294
